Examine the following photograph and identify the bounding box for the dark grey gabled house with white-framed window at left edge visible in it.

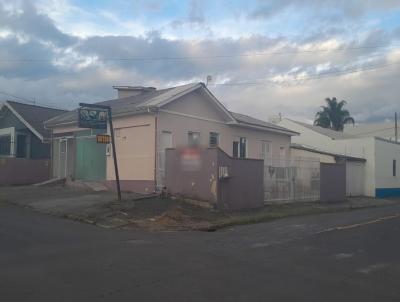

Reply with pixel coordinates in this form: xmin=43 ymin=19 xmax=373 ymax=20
xmin=0 ymin=101 xmax=66 ymax=185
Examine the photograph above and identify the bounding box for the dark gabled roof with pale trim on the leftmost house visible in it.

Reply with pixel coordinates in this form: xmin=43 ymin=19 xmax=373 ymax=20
xmin=0 ymin=101 xmax=67 ymax=141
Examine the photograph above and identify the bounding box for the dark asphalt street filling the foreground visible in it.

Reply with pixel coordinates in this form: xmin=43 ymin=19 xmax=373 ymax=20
xmin=0 ymin=205 xmax=400 ymax=302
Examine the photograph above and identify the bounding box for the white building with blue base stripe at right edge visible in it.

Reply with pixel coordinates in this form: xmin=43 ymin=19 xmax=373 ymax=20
xmin=278 ymin=118 xmax=400 ymax=197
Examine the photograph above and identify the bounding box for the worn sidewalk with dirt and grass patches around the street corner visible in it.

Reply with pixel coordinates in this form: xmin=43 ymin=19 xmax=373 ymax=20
xmin=0 ymin=186 xmax=400 ymax=231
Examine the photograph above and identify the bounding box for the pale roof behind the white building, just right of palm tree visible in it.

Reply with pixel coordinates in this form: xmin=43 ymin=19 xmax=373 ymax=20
xmin=343 ymin=122 xmax=396 ymax=141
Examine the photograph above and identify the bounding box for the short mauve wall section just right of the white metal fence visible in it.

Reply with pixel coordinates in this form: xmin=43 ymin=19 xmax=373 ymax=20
xmin=320 ymin=163 xmax=346 ymax=202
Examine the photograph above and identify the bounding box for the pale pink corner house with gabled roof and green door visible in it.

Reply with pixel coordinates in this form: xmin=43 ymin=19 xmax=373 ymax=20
xmin=46 ymin=83 xmax=296 ymax=192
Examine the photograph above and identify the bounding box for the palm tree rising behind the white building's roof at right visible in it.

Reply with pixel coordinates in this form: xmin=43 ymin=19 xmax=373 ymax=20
xmin=314 ymin=97 xmax=354 ymax=131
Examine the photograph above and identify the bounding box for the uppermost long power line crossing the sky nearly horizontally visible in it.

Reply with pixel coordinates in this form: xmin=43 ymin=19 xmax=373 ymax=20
xmin=0 ymin=44 xmax=400 ymax=63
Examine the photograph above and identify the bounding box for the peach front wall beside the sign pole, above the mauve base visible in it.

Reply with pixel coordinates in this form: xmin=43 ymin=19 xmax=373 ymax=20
xmin=107 ymin=114 xmax=155 ymax=180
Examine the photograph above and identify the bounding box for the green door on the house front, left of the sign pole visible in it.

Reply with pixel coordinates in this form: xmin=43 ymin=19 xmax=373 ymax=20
xmin=75 ymin=131 xmax=107 ymax=181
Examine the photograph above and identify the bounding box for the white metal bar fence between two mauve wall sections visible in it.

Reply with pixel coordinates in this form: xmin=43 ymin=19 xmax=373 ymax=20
xmin=264 ymin=158 xmax=320 ymax=202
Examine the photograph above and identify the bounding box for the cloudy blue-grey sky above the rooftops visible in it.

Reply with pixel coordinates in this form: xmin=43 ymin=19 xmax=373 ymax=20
xmin=0 ymin=0 xmax=400 ymax=122
